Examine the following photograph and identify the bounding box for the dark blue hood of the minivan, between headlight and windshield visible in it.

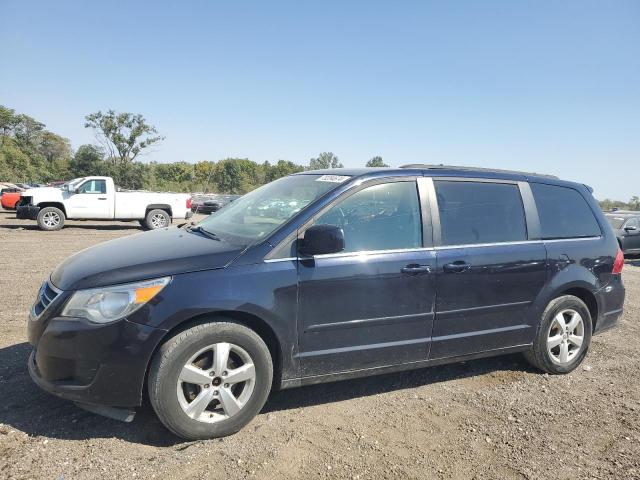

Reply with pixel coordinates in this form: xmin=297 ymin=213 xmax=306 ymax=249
xmin=51 ymin=228 xmax=244 ymax=290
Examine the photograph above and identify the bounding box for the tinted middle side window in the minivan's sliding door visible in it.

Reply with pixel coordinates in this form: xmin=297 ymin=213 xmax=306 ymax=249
xmin=434 ymin=180 xmax=527 ymax=245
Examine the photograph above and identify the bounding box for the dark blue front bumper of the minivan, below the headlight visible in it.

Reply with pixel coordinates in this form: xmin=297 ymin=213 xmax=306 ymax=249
xmin=28 ymin=315 xmax=165 ymax=407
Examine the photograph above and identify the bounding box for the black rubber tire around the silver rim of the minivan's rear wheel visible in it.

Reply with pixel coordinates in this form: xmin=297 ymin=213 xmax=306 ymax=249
xmin=533 ymin=295 xmax=593 ymax=374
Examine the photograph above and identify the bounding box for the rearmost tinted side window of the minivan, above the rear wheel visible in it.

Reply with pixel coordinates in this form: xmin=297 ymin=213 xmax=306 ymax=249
xmin=531 ymin=183 xmax=602 ymax=239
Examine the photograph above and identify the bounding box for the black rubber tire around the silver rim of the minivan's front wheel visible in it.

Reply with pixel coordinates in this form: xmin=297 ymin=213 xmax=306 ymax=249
xmin=149 ymin=322 xmax=273 ymax=440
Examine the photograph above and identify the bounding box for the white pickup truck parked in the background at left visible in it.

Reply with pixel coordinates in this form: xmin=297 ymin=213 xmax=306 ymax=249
xmin=17 ymin=177 xmax=192 ymax=230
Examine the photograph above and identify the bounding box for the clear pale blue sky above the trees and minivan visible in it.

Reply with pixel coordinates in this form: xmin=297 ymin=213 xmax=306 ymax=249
xmin=0 ymin=0 xmax=640 ymax=200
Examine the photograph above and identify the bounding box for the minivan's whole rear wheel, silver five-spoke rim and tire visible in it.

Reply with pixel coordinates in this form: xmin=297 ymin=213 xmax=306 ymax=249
xmin=524 ymin=295 xmax=593 ymax=375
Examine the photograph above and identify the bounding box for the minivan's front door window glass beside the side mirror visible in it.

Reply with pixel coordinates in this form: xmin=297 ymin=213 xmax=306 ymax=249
xmin=315 ymin=182 xmax=422 ymax=252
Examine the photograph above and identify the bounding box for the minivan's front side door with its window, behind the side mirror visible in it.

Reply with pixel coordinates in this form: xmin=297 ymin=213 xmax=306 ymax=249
xmin=298 ymin=178 xmax=436 ymax=376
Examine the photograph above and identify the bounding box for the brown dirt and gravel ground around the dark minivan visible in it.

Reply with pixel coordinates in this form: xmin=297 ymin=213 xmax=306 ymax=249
xmin=0 ymin=211 xmax=640 ymax=480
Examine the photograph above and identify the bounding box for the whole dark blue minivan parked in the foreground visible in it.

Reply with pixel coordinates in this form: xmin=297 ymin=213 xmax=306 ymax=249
xmin=28 ymin=165 xmax=624 ymax=439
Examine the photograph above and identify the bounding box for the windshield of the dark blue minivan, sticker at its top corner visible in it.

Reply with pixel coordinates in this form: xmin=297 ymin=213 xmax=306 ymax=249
xmin=199 ymin=175 xmax=349 ymax=245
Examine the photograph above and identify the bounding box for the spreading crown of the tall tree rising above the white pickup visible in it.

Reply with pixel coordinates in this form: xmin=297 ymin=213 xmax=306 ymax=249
xmin=84 ymin=110 xmax=164 ymax=164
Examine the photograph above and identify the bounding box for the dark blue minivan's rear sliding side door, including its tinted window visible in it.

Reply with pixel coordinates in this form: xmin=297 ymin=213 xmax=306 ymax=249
xmin=430 ymin=180 xmax=547 ymax=359
